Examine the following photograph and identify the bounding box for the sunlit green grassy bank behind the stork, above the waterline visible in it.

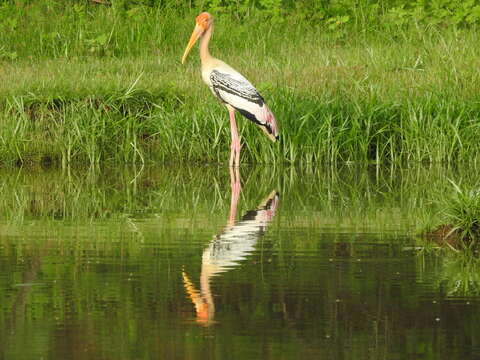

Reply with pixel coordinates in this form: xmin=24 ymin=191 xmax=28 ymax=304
xmin=0 ymin=3 xmax=480 ymax=164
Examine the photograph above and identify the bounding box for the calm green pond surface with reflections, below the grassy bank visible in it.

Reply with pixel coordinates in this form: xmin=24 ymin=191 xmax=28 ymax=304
xmin=0 ymin=166 xmax=480 ymax=359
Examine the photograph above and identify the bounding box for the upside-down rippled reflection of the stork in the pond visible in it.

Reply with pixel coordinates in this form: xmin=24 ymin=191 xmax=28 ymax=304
xmin=182 ymin=167 xmax=279 ymax=326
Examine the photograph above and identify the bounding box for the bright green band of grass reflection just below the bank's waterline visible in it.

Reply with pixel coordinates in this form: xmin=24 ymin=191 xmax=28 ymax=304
xmin=0 ymin=166 xmax=474 ymax=234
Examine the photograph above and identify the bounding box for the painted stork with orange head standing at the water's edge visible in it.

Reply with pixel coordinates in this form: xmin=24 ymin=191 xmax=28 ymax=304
xmin=182 ymin=12 xmax=279 ymax=166
